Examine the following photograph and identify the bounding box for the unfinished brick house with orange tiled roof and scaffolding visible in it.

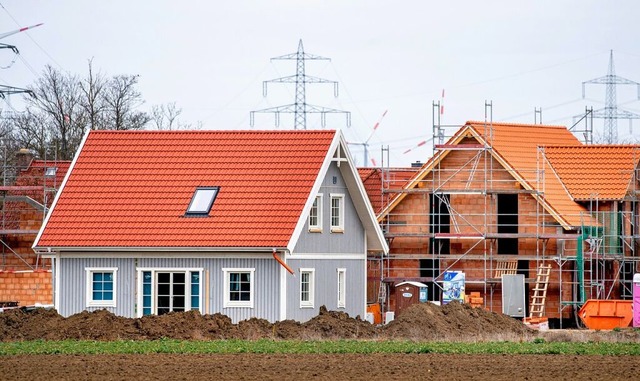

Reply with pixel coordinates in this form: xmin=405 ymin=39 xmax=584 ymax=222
xmin=361 ymin=121 xmax=640 ymax=328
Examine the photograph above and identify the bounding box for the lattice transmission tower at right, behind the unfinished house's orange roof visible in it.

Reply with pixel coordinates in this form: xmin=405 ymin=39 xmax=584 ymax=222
xmin=582 ymin=50 xmax=640 ymax=144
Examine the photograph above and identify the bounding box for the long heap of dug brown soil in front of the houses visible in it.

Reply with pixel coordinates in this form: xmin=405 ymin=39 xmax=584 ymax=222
xmin=0 ymin=302 xmax=535 ymax=341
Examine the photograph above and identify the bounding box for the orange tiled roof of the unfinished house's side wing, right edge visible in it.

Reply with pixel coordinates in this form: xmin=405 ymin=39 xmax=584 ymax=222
xmin=544 ymin=145 xmax=640 ymax=201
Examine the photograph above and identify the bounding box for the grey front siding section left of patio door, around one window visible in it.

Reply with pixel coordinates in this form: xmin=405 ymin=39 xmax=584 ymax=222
xmin=56 ymin=258 xmax=136 ymax=317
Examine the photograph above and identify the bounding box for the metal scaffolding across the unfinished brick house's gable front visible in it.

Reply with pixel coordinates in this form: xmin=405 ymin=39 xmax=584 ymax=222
xmin=369 ymin=103 xmax=640 ymax=328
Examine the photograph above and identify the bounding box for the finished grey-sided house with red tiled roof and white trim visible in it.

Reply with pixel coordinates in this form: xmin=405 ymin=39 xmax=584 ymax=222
xmin=34 ymin=131 xmax=388 ymax=322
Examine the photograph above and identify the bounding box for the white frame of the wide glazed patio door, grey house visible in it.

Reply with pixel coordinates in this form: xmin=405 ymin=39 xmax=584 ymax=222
xmin=136 ymin=267 xmax=204 ymax=317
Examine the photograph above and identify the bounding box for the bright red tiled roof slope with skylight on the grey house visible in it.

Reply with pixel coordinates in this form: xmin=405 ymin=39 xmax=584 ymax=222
xmin=36 ymin=131 xmax=336 ymax=248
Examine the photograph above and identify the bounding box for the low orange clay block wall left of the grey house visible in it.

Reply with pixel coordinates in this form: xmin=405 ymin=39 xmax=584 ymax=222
xmin=0 ymin=270 xmax=53 ymax=306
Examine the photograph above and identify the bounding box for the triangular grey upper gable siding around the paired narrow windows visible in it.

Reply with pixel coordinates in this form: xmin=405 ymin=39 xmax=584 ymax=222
xmin=294 ymin=163 xmax=365 ymax=254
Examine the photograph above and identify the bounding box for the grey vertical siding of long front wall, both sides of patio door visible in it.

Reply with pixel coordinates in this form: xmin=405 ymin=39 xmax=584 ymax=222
xmin=57 ymin=253 xmax=281 ymax=323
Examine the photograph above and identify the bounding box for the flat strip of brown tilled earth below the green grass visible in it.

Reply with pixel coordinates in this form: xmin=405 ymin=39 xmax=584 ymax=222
xmin=0 ymin=354 xmax=640 ymax=381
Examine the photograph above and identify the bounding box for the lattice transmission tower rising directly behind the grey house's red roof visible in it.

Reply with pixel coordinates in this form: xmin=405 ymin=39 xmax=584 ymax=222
xmin=250 ymin=40 xmax=351 ymax=130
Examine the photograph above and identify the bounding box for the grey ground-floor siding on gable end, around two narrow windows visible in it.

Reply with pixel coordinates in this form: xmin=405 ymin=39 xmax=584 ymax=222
xmin=287 ymin=259 xmax=367 ymax=321
